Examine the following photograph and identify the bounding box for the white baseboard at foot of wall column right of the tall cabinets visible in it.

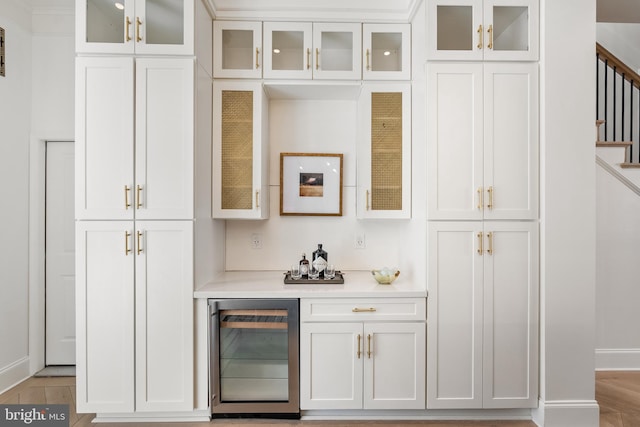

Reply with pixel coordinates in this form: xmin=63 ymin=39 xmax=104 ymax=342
xmin=531 ymin=400 xmax=600 ymax=427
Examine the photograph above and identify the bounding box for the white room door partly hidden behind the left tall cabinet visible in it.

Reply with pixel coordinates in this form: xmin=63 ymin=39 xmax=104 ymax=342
xmin=45 ymin=142 xmax=76 ymax=365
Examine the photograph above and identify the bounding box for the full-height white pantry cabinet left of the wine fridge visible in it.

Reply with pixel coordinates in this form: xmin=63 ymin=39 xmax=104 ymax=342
xmin=75 ymin=0 xmax=212 ymax=415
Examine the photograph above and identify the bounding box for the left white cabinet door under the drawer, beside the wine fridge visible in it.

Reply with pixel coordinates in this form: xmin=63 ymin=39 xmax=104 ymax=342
xmin=300 ymin=323 xmax=366 ymax=410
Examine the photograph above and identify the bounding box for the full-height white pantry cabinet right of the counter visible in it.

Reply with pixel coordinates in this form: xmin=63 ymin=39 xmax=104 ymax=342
xmin=427 ymin=0 xmax=539 ymax=409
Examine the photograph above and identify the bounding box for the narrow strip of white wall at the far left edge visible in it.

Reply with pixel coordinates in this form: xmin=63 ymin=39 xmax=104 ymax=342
xmin=0 ymin=1 xmax=32 ymax=390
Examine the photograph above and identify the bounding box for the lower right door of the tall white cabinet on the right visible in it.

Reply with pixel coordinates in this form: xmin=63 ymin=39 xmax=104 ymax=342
xmin=482 ymin=221 xmax=539 ymax=408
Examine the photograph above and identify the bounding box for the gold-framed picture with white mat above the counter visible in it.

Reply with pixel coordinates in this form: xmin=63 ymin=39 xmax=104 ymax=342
xmin=280 ymin=153 xmax=342 ymax=216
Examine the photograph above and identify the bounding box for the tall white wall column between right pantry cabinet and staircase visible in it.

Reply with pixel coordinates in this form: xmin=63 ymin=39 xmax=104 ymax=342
xmin=535 ymin=0 xmax=599 ymax=427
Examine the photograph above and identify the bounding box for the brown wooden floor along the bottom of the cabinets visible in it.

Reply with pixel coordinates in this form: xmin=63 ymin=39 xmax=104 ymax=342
xmin=0 ymin=371 xmax=640 ymax=427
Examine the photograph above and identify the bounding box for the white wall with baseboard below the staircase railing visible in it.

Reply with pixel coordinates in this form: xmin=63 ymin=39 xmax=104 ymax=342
xmin=596 ymin=157 xmax=640 ymax=369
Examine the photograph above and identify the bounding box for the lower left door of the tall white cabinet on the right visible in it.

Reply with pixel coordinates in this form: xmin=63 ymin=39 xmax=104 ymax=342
xmin=427 ymin=221 xmax=485 ymax=409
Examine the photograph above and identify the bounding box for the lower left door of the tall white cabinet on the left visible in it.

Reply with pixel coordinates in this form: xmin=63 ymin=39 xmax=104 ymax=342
xmin=76 ymin=221 xmax=135 ymax=413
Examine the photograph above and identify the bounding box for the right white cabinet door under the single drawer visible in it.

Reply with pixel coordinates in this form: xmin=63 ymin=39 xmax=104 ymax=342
xmin=363 ymin=323 xmax=426 ymax=409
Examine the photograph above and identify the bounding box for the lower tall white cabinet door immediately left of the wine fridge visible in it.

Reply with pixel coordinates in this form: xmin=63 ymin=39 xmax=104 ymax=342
xmin=135 ymin=221 xmax=194 ymax=412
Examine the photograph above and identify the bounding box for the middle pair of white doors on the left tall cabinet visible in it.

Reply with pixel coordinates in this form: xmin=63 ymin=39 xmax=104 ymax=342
xmin=76 ymin=57 xmax=194 ymax=219
